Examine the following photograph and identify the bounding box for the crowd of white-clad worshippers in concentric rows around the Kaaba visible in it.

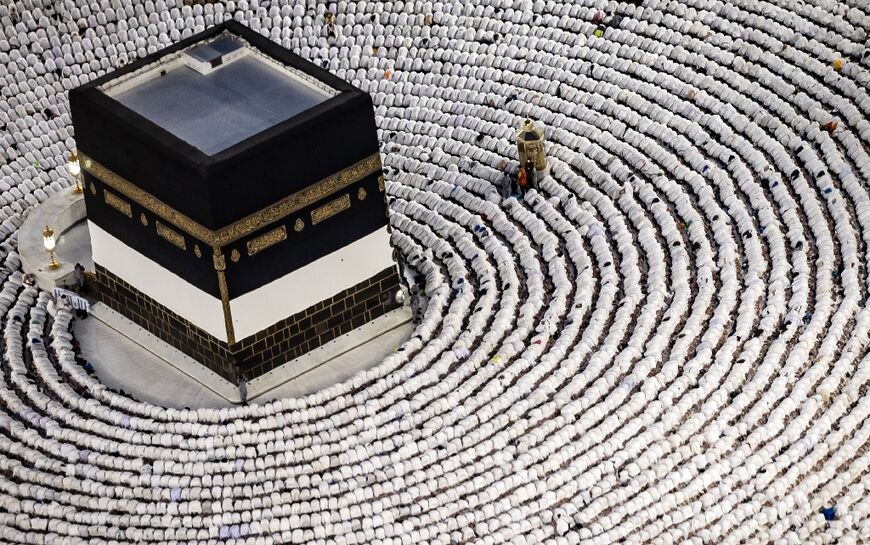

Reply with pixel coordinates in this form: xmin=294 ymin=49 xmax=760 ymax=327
xmin=0 ymin=0 xmax=870 ymax=545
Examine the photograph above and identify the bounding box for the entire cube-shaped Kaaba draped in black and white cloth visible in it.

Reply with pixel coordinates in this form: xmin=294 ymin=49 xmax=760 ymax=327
xmin=69 ymin=21 xmax=399 ymax=381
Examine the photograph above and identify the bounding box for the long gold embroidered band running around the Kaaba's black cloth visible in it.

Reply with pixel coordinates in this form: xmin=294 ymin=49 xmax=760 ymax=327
xmin=79 ymin=151 xmax=381 ymax=248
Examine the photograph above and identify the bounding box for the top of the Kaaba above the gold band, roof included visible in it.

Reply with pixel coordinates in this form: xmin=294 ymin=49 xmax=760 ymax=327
xmin=69 ymin=20 xmax=379 ymax=230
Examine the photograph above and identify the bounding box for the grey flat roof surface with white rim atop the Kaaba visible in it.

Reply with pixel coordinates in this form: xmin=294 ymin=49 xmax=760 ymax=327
xmin=101 ymin=32 xmax=337 ymax=155
